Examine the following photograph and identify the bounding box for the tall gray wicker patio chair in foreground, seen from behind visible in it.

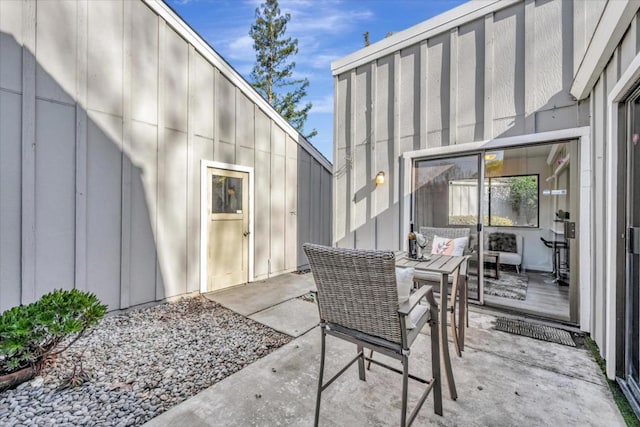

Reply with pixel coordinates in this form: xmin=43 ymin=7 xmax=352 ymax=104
xmin=303 ymin=243 xmax=442 ymax=427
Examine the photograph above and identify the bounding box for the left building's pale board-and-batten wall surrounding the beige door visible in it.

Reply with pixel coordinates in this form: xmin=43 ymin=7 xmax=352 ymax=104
xmin=0 ymin=0 xmax=331 ymax=310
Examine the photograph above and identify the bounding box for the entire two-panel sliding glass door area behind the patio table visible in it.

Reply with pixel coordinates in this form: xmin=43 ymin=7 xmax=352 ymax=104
xmin=410 ymin=141 xmax=579 ymax=323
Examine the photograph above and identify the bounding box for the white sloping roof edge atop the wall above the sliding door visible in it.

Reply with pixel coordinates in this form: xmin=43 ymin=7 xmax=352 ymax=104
xmin=331 ymin=0 xmax=524 ymax=76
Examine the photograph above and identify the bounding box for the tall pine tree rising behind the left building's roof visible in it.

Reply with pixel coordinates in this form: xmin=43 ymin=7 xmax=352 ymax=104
xmin=249 ymin=0 xmax=318 ymax=138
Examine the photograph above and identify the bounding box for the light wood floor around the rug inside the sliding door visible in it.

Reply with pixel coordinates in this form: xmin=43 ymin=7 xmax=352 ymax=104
xmin=468 ymin=271 xmax=569 ymax=321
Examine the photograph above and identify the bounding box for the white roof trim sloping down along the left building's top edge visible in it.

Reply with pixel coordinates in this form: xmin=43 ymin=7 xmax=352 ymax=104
xmin=142 ymin=0 xmax=333 ymax=172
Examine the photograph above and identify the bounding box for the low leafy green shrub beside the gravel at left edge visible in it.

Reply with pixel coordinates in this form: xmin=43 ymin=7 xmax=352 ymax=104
xmin=0 ymin=289 xmax=107 ymax=390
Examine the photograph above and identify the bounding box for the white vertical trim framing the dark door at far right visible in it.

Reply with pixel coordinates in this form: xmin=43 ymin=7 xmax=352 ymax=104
xmin=604 ymin=50 xmax=640 ymax=379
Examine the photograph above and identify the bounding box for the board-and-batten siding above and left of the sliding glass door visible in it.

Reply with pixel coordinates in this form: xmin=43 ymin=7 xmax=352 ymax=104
xmin=332 ymin=0 xmax=592 ymax=249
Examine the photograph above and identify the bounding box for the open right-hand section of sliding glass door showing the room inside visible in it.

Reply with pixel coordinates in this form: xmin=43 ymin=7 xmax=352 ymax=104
xmin=483 ymin=141 xmax=578 ymax=322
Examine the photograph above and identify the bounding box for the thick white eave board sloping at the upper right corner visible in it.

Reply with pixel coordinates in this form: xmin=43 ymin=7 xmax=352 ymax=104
xmin=570 ymin=0 xmax=640 ymax=100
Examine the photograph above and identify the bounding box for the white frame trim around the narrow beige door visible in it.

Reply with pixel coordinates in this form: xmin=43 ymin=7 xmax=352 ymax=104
xmin=200 ymin=160 xmax=255 ymax=293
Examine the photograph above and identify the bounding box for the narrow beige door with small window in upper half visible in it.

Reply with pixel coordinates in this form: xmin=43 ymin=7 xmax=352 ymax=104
xmin=207 ymin=168 xmax=249 ymax=292
